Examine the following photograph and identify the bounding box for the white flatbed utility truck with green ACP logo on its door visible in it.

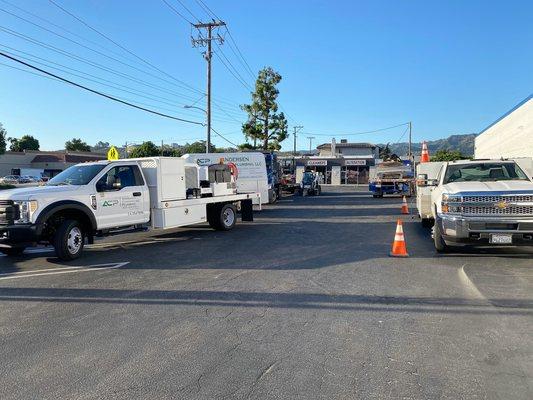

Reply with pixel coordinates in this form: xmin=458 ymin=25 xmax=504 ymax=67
xmin=0 ymin=157 xmax=260 ymax=260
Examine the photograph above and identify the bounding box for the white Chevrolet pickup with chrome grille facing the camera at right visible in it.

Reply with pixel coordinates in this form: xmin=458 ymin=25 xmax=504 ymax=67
xmin=417 ymin=160 xmax=533 ymax=252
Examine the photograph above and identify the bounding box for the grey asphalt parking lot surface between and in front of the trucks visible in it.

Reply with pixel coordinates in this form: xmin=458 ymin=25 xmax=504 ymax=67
xmin=0 ymin=188 xmax=533 ymax=399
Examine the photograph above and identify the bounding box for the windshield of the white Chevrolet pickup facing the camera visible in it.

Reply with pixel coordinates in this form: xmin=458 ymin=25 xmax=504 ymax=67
xmin=444 ymin=163 xmax=528 ymax=184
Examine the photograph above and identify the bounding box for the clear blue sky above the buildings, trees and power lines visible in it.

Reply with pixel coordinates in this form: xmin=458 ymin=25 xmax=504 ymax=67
xmin=0 ymin=0 xmax=533 ymax=150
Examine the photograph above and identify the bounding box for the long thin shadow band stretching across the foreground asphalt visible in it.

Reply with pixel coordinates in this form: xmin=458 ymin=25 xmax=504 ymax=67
xmin=0 ymin=288 xmax=533 ymax=315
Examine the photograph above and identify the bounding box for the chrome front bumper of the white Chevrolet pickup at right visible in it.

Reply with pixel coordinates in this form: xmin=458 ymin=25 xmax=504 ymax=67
xmin=435 ymin=214 xmax=533 ymax=246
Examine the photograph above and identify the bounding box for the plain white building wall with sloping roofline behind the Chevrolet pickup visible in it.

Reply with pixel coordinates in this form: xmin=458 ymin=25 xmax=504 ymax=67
xmin=475 ymin=96 xmax=533 ymax=158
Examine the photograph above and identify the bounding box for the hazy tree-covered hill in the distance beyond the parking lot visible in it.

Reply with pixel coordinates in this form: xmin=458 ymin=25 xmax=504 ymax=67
xmin=378 ymin=133 xmax=476 ymax=156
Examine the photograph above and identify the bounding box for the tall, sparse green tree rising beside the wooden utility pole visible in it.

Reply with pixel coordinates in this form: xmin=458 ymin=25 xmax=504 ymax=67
xmin=241 ymin=67 xmax=288 ymax=150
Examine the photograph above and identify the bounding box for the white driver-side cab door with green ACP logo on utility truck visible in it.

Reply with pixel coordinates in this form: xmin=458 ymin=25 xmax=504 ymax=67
xmin=96 ymin=165 xmax=150 ymax=229
